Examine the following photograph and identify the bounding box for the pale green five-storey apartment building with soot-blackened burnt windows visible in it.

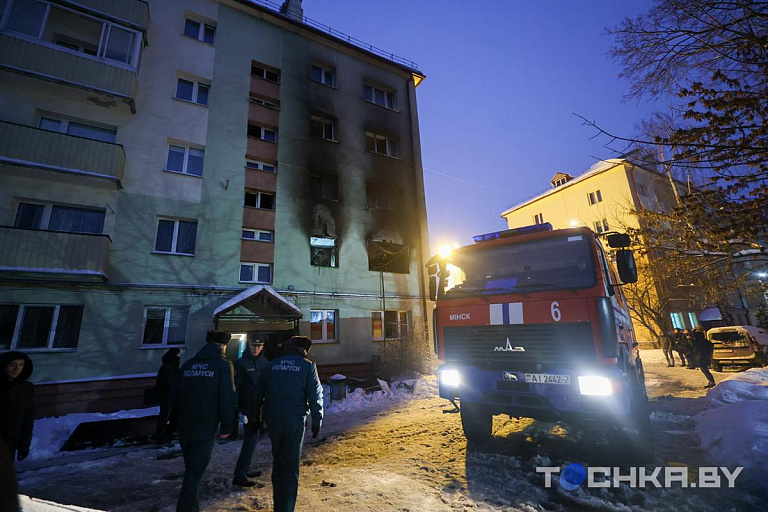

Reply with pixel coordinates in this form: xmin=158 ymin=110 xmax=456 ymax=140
xmin=0 ymin=0 xmax=428 ymax=412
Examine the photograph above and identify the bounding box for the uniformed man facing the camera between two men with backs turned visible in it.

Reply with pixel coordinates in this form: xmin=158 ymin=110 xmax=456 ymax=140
xmin=232 ymin=334 xmax=267 ymax=487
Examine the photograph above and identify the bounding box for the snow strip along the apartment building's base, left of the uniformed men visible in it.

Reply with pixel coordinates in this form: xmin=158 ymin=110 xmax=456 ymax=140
xmin=29 ymin=407 xmax=160 ymax=460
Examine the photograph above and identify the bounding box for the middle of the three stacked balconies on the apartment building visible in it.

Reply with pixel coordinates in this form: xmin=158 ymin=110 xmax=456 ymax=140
xmin=0 ymin=121 xmax=125 ymax=188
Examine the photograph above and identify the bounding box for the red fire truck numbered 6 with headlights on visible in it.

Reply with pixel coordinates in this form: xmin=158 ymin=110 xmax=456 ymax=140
xmin=428 ymin=223 xmax=650 ymax=442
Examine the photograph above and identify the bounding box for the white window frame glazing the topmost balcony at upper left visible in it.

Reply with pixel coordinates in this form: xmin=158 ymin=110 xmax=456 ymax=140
xmin=0 ymin=0 xmax=142 ymax=71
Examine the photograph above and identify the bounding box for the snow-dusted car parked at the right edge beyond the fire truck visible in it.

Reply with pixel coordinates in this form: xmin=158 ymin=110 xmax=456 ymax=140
xmin=707 ymin=325 xmax=768 ymax=371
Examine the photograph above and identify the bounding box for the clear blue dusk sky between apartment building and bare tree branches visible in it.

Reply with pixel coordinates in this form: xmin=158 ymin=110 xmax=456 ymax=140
xmin=303 ymin=0 xmax=653 ymax=252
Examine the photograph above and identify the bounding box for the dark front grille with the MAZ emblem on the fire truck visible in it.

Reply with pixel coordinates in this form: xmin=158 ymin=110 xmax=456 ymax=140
xmin=443 ymin=322 xmax=596 ymax=371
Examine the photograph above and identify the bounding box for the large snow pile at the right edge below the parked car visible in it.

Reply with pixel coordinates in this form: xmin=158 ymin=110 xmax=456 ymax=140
xmin=694 ymin=368 xmax=768 ymax=471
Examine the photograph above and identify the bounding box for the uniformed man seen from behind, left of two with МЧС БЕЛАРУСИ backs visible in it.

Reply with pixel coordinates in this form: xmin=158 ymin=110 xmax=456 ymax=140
xmin=176 ymin=331 xmax=235 ymax=512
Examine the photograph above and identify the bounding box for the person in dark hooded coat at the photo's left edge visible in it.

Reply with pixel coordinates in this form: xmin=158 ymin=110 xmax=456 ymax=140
xmin=0 ymin=351 xmax=35 ymax=461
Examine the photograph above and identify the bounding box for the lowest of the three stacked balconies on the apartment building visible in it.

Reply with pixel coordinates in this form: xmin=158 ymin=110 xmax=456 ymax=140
xmin=0 ymin=226 xmax=112 ymax=282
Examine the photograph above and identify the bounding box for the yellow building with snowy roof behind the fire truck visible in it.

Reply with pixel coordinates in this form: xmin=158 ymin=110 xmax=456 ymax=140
xmin=501 ymin=157 xmax=698 ymax=341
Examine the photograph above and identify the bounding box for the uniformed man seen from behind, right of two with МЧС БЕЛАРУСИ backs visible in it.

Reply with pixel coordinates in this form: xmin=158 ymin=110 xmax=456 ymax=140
xmin=256 ymin=336 xmax=323 ymax=512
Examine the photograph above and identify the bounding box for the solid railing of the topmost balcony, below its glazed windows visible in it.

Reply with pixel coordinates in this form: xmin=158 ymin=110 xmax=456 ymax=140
xmin=0 ymin=34 xmax=138 ymax=104
